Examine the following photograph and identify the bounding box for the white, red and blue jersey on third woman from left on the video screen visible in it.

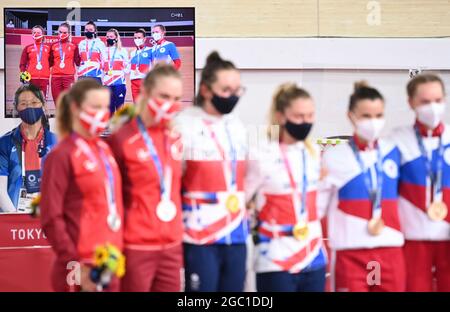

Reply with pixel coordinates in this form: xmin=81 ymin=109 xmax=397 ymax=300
xmin=78 ymin=38 xmax=107 ymax=78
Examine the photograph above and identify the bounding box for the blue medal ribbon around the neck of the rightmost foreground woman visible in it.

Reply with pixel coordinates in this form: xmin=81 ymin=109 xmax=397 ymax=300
xmin=414 ymin=127 xmax=444 ymax=200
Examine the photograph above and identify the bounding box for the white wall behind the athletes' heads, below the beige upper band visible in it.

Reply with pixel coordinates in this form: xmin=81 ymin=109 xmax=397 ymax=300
xmin=0 ymin=38 xmax=450 ymax=137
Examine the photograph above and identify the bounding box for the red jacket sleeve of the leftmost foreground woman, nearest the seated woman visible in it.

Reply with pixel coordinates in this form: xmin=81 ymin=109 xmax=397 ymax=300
xmin=40 ymin=149 xmax=79 ymax=263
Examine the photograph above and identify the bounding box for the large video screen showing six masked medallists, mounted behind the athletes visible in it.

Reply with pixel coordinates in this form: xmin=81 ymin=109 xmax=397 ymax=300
xmin=4 ymin=8 xmax=195 ymax=118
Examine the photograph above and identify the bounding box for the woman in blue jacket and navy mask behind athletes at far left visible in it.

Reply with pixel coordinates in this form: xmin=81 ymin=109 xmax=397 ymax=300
xmin=0 ymin=84 xmax=56 ymax=212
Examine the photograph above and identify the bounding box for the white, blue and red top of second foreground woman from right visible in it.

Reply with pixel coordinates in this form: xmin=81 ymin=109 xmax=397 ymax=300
xmin=318 ymin=140 xmax=404 ymax=250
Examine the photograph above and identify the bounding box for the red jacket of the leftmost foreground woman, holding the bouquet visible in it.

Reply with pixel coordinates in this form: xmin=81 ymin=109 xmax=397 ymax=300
xmin=40 ymin=135 xmax=123 ymax=291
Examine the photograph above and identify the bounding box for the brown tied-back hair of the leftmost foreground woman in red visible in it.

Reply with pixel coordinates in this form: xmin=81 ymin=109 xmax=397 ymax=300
xmin=56 ymin=78 xmax=106 ymax=138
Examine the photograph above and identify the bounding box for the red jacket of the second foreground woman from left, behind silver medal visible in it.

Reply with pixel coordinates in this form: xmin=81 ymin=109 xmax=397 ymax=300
xmin=108 ymin=118 xmax=183 ymax=250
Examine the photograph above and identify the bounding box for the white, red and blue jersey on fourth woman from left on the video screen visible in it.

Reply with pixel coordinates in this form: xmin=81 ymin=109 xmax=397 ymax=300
xmin=102 ymin=47 xmax=129 ymax=86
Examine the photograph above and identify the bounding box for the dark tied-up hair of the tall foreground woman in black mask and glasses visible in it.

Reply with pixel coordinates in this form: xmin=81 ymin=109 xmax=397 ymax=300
xmin=194 ymin=51 xmax=237 ymax=106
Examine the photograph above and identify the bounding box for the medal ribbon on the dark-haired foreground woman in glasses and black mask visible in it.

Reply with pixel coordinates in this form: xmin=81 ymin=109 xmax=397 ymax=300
xmin=203 ymin=120 xmax=237 ymax=191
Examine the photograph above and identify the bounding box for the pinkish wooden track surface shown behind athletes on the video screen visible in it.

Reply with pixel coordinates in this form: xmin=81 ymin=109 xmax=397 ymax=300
xmin=5 ymin=39 xmax=194 ymax=117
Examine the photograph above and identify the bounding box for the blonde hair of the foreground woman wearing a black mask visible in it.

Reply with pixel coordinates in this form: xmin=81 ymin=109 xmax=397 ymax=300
xmin=267 ymin=82 xmax=316 ymax=157
